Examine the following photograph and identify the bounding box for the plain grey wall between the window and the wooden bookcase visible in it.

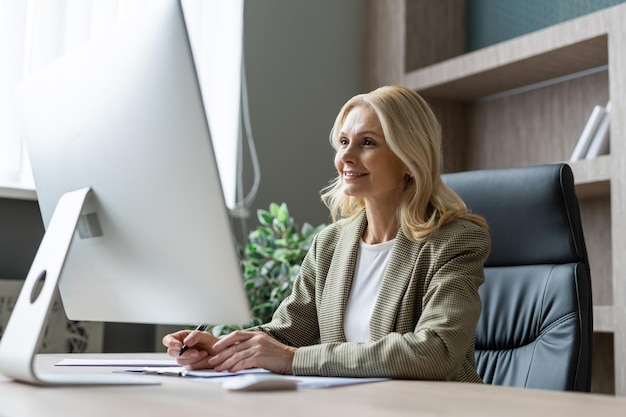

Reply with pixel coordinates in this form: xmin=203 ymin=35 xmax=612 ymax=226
xmin=238 ymin=0 xmax=365 ymax=237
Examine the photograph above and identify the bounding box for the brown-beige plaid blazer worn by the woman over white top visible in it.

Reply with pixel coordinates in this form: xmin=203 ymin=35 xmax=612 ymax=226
xmin=259 ymin=210 xmax=491 ymax=382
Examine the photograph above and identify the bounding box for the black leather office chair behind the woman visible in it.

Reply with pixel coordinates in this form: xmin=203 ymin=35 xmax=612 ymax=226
xmin=444 ymin=164 xmax=593 ymax=391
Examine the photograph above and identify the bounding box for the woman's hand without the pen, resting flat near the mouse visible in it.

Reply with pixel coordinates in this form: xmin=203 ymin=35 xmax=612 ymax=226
xmin=205 ymin=330 xmax=297 ymax=375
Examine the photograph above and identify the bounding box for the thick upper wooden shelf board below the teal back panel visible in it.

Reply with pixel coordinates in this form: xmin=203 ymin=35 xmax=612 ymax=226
xmin=403 ymin=13 xmax=608 ymax=101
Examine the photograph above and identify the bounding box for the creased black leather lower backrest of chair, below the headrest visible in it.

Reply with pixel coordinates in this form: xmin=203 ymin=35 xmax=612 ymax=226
xmin=476 ymin=263 xmax=591 ymax=391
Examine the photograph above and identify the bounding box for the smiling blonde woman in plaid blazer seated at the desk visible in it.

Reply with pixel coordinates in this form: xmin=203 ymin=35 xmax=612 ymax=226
xmin=163 ymin=86 xmax=491 ymax=382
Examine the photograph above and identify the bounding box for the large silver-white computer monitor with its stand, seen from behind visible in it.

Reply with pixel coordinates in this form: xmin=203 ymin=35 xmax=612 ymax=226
xmin=0 ymin=0 xmax=250 ymax=383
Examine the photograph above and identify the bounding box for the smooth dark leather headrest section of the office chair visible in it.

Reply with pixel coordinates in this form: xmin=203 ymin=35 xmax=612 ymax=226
xmin=443 ymin=163 xmax=587 ymax=266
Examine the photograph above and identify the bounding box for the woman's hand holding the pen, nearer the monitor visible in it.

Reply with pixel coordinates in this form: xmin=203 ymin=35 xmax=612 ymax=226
xmin=162 ymin=330 xmax=219 ymax=369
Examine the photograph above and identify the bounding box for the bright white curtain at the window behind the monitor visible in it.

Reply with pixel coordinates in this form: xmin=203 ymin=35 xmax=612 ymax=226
xmin=0 ymin=0 xmax=244 ymax=207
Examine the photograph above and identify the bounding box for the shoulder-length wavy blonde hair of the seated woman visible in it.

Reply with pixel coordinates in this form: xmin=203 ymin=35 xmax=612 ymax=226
xmin=321 ymin=86 xmax=487 ymax=241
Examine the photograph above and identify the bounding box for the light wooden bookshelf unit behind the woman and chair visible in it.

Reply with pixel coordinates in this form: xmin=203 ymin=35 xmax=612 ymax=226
xmin=365 ymin=0 xmax=626 ymax=395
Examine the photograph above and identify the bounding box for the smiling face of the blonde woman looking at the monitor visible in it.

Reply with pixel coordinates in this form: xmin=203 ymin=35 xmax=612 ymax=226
xmin=335 ymin=105 xmax=407 ymax=205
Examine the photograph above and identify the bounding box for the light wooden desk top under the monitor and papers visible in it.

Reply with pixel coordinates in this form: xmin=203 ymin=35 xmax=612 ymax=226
xmin=0 ymin=354 xmax=626 ymax=417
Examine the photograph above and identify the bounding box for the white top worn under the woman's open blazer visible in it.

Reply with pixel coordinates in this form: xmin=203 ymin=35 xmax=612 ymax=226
xmin=343 ymin=239 xmax=395 ymax=343
